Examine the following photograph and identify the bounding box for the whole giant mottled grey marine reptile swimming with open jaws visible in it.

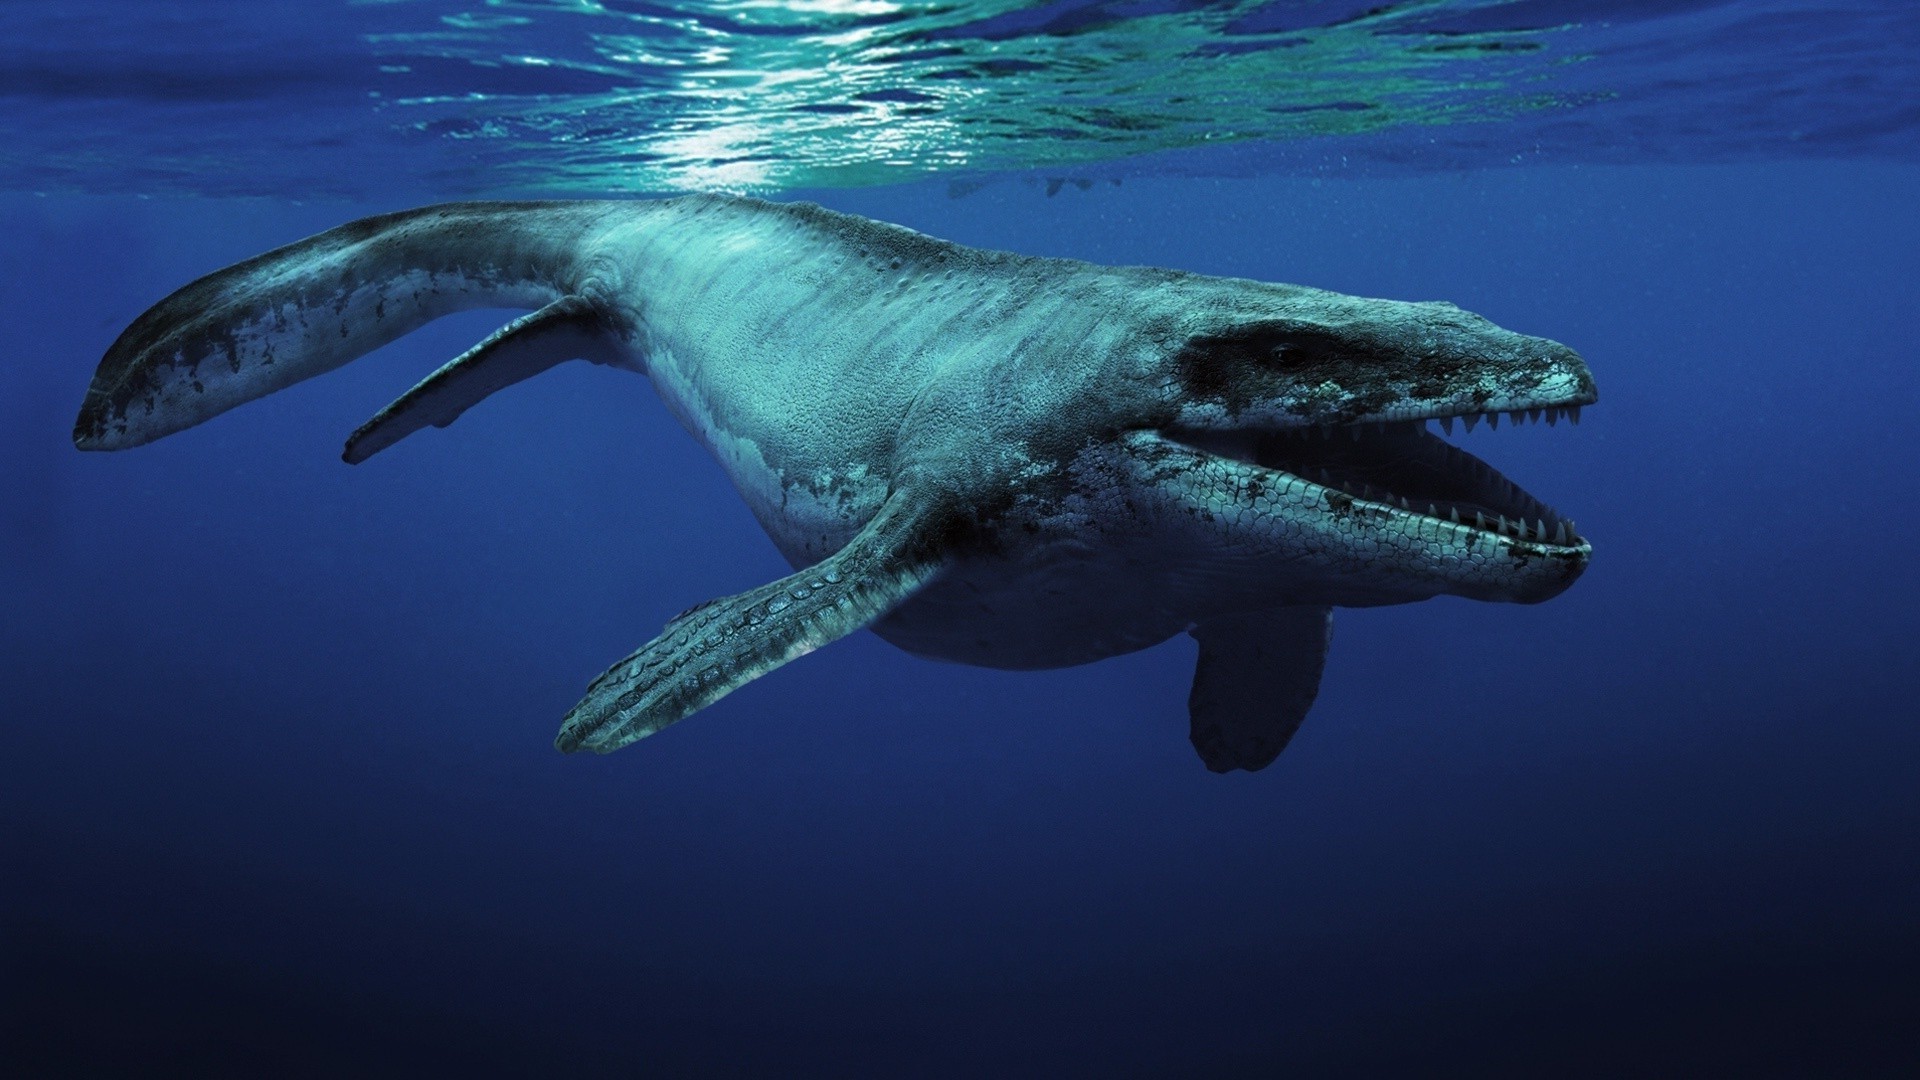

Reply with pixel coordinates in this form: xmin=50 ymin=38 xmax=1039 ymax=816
xmin=75 ymin=196 xmax=1594 ymax=769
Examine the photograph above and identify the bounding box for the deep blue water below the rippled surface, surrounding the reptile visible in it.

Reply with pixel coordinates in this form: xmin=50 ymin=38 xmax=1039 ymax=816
xmin=0 ymin=163 xmax=1920 ymax=1076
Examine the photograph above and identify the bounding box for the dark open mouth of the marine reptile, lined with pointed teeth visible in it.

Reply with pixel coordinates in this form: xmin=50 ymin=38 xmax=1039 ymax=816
xmin=1165 ymin=405 xmax=1588 ymax=552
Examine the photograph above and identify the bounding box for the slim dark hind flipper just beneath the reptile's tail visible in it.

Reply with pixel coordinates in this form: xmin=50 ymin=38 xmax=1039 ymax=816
xmin=340 ymin=296 xmax=618 ymax=465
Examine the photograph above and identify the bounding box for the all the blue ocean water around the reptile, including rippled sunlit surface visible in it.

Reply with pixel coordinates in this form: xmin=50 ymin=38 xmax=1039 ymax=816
xmin=0 ymin=0 xmax=1920 ymax=1076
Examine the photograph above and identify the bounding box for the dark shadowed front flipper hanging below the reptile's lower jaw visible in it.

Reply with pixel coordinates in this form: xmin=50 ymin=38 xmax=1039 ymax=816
xmin=1187 ymin=607 xmax=1332 ymax=773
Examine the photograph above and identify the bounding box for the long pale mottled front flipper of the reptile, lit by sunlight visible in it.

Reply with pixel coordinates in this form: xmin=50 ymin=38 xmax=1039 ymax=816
xmin=553 ymin=492 xmax=941 ymax=753
